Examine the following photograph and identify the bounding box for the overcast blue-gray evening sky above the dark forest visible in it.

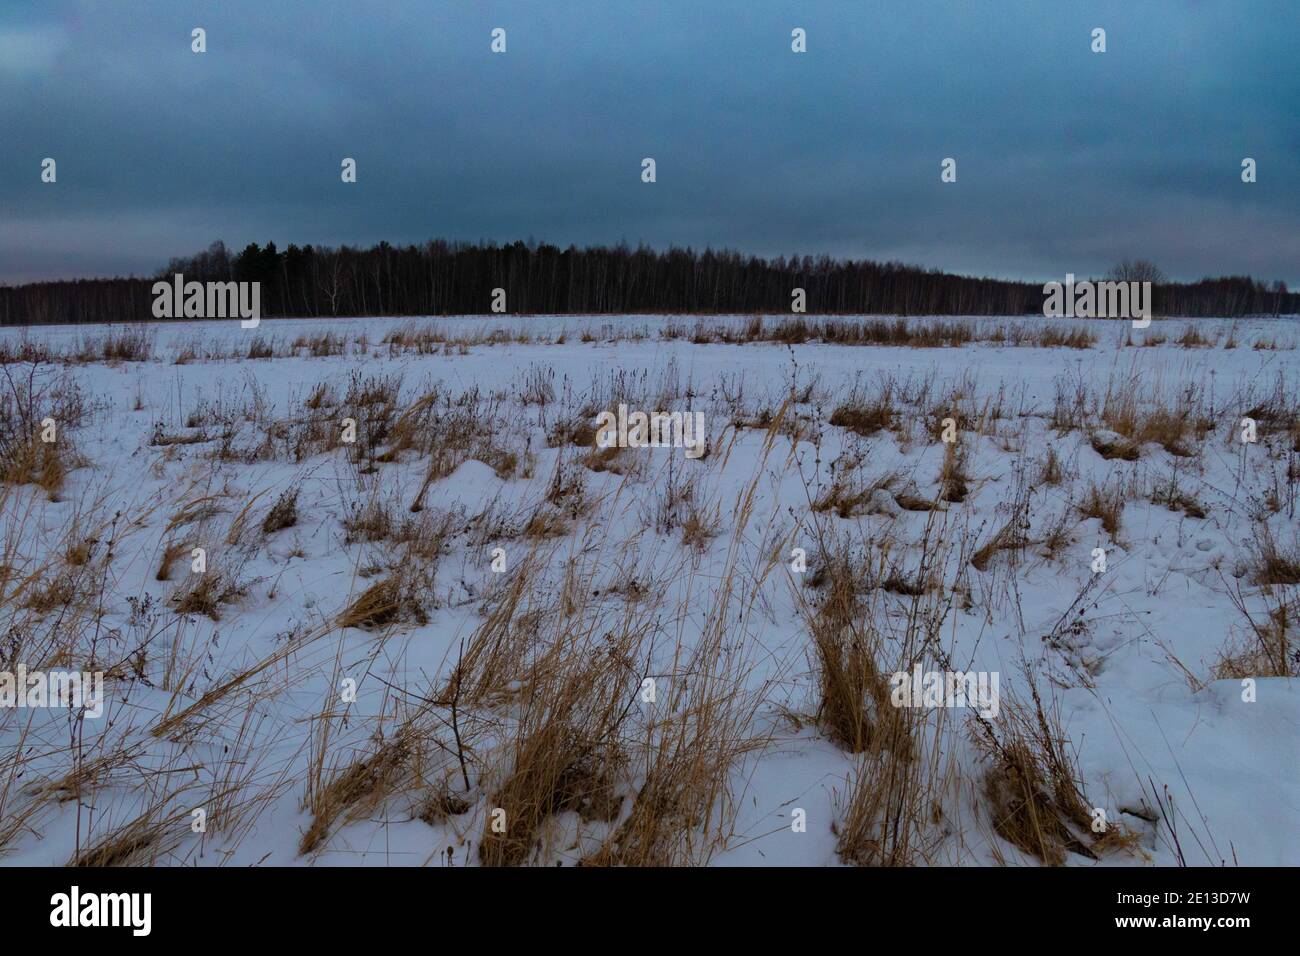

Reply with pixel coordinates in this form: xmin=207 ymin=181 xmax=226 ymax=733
xmin=0 ymin=0 xmax=1300 ymax=287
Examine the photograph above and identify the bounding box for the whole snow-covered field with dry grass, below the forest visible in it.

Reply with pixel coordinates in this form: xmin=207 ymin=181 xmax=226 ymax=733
xmin=0 ymin=316 xmax=1300 ymax=866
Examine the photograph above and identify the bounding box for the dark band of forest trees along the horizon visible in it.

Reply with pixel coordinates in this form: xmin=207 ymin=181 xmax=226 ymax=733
xmin=0 ymin=239 xmax=1300 ymax=325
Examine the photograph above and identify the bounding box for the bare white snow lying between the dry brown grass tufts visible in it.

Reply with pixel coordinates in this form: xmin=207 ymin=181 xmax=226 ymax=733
xmin=0 ymin=316 xmax=1300 ymax=865
